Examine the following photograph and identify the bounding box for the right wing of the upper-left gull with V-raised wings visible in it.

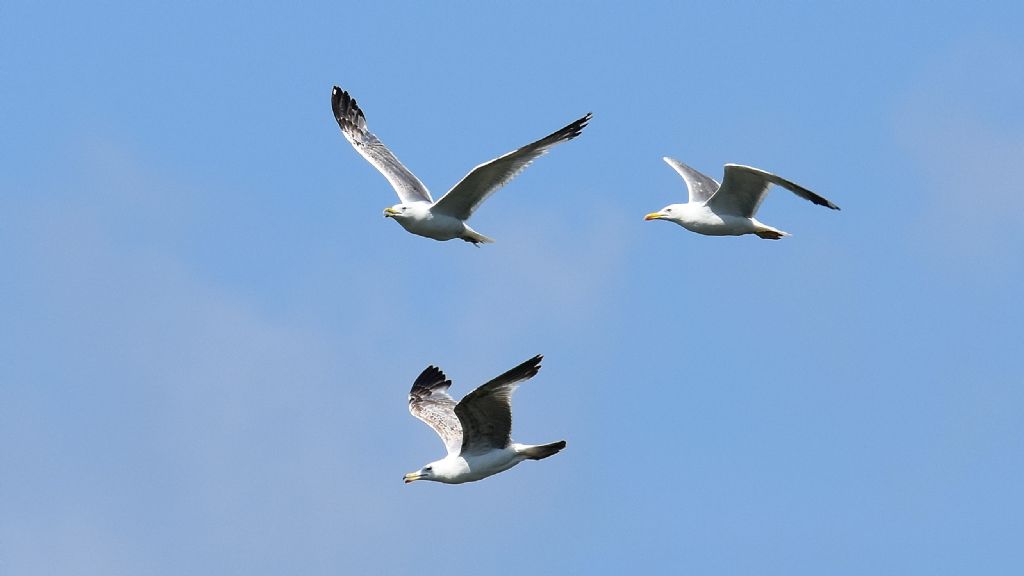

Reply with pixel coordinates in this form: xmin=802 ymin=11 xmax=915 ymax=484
xmin=431 ymin=113 xmax=591 ymax=220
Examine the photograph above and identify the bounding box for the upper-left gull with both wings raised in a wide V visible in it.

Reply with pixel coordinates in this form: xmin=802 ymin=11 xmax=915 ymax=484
xmin=331 ymin=86 xmax=591 ymax=246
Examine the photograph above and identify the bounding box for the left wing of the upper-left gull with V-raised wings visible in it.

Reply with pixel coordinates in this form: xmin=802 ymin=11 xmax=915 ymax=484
xmin=331 ymin=86 xmax=433 ymax=203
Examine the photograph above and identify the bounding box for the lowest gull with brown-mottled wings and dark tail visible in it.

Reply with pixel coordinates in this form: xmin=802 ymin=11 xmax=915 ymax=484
xmin=406 ymin=356 xmax=565 ymax=484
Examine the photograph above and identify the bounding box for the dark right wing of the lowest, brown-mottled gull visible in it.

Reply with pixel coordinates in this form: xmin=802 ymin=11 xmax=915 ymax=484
xmin=455 ymin=356 xmax=544 ymax=454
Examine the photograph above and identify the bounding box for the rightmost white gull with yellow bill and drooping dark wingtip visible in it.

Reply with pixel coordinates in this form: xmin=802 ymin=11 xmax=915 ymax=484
xmin=644 ymin=157 xmax=839 ymax=240
